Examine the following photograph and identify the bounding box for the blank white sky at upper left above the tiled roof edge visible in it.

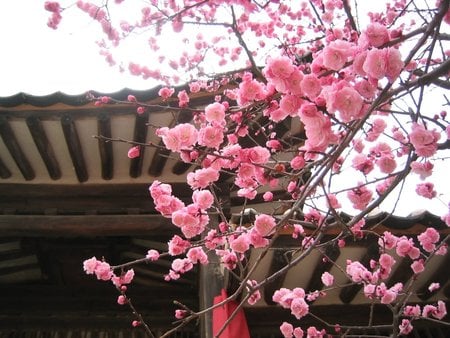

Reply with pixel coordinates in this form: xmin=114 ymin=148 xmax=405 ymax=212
xmin=0 ymin=0 xmax=155 ymax=96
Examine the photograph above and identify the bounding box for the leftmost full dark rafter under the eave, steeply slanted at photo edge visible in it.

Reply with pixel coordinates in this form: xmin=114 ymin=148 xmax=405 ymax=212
xmin=0 ymin=116 xmax=36 ymax=181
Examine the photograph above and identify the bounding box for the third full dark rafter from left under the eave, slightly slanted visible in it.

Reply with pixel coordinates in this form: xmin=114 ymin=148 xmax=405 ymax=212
xmin=61 ymin=114 xmax=89 ymax=182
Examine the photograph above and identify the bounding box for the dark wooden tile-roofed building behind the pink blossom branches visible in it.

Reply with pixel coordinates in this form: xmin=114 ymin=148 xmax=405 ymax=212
xmin=0 ymin=88 xmax=450 ymax=338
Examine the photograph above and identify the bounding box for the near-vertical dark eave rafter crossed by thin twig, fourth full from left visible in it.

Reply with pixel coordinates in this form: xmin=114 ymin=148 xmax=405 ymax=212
xmin=97 ymin=113 xmax=114 ymax=180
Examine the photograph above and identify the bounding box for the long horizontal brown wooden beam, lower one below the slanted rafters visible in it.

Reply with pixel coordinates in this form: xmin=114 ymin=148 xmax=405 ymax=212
xmin=0 ymin=215 xmax=176 ymax=237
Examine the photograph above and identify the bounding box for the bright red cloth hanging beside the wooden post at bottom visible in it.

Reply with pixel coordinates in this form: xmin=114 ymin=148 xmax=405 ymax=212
xmin=213 ymin=289 xmax=250 ymax=338
